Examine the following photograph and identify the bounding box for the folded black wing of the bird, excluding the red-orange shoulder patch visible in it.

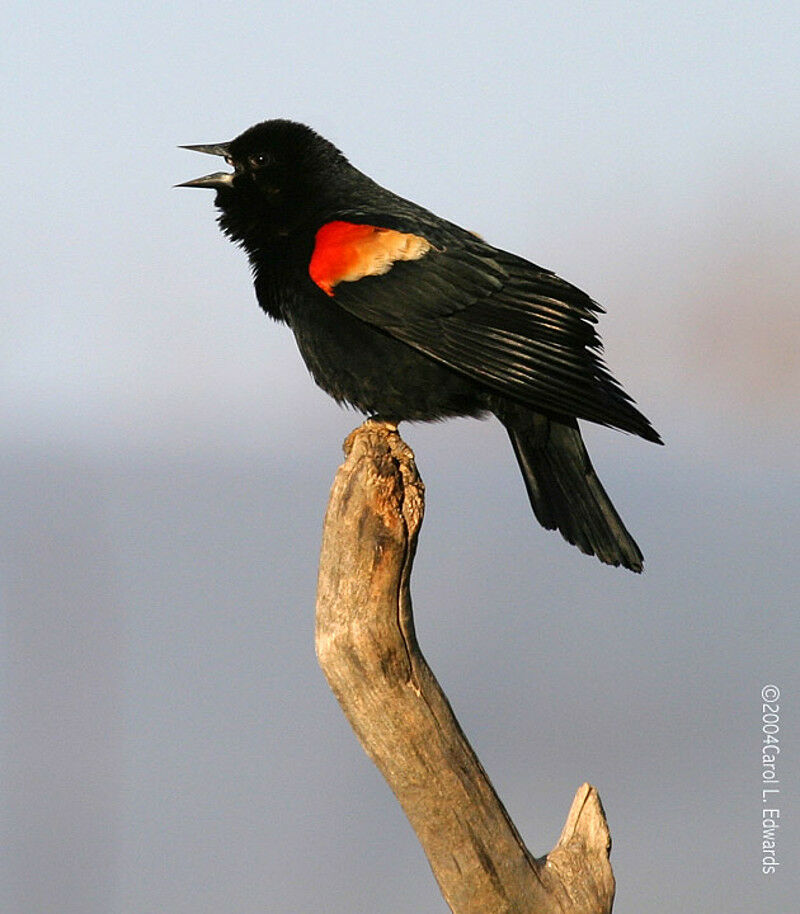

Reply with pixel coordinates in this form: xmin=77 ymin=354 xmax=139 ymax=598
xmin=322 ymin=207 xmax=660 ymax=441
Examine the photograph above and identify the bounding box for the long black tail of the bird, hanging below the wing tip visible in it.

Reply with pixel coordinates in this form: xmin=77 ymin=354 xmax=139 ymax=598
xmin=501 ymin=411 xmax=644 ymax=572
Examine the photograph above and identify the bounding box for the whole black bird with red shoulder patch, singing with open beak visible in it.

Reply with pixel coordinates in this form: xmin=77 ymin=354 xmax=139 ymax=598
xmin=180 ymin=120 xmax=661 ymax=571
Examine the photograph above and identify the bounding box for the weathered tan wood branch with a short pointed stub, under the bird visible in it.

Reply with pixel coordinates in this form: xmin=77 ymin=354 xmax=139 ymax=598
xmin=316 ymin=421 xmax=614 ymax=914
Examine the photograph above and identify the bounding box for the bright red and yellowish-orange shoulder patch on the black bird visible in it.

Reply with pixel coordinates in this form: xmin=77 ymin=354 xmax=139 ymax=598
xmin=308 ymin=221 xmax=433 ymax=296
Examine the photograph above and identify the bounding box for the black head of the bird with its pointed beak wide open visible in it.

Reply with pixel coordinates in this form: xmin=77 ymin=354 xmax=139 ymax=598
xmin=178 ymin=120 xmax=358 ymax=249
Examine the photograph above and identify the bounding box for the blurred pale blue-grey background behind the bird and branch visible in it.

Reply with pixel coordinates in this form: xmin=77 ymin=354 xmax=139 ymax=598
xmin=0 ymin=0 xmax=800 ymax=914
